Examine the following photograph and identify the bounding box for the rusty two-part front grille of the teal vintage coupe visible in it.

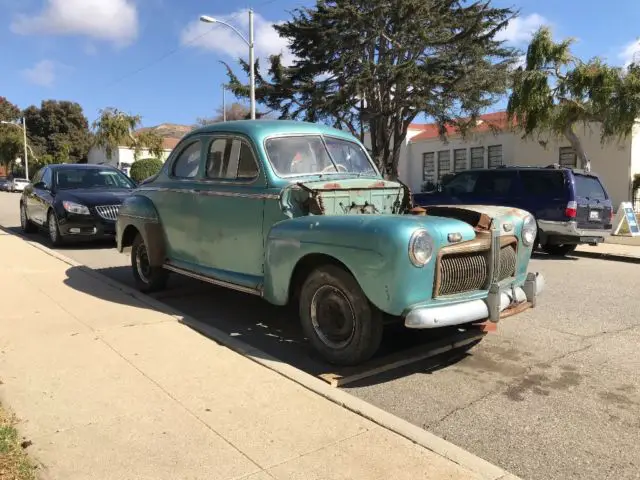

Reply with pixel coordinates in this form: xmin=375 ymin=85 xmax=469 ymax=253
xmin=434 ymin=243 xmax=517 ymax=297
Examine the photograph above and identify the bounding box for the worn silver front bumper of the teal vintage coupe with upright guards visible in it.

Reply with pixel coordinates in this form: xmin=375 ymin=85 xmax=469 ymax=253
xmin=404 ymin=272 xmax=544 ymax=328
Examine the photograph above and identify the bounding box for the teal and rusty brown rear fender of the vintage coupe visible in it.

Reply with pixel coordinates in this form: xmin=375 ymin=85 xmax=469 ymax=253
xmin=116 ymin=193 xmax=166 ymax=266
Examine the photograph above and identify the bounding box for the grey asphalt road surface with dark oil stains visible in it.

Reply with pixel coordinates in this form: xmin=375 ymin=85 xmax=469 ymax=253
xmin=0 ymin=192 xmax=640 ymax=480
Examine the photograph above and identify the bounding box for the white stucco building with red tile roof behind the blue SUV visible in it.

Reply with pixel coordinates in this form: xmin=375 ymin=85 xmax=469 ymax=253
xmin=372 ymin=112 xmax=640 ymax=208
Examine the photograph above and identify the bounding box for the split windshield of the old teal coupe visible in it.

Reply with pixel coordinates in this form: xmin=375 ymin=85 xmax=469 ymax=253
xmin=265 ymin=135 xmax=378 ymax=177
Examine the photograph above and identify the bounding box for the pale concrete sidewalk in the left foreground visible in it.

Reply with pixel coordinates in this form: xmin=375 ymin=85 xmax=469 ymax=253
xmin=0 ymin=231 xmax=516 ymax=480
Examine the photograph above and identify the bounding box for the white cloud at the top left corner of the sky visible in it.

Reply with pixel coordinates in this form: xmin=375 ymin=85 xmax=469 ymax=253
xmin=11 ymin=0 xmax=138 ymax=46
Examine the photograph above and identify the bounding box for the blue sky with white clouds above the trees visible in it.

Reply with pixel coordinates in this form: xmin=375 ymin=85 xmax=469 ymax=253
xmin=0 ymin=0 xmax=640 ymax=126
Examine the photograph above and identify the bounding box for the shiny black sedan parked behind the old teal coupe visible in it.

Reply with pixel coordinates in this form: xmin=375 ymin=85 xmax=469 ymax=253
xmin=20 ymin=164 xmax=136 ymax=246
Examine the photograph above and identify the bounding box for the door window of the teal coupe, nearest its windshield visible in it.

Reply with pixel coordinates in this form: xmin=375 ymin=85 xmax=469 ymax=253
xmin=207 ymin=138 xmax=259 ymax=181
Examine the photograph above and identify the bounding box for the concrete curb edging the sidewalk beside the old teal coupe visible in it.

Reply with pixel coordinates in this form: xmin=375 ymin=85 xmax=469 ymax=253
xmin=6 ymin=227 xmax=518 ymax=480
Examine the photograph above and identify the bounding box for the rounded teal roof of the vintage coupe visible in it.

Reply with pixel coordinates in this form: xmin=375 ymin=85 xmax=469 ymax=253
xmin=185 ymin=120 xmax=354 ymax=140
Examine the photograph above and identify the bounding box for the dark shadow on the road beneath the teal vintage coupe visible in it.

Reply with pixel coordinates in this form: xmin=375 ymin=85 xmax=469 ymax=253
xmin=65 ymin=267 xmax=480 ymax=387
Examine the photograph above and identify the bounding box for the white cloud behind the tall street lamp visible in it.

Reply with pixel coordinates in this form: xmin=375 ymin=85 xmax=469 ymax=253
xmin=180 ymin=10 xmax=294 ymax=65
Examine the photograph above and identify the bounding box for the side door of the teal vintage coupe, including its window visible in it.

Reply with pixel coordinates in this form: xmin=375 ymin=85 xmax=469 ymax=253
xmin=197 ymin=135 xmax=267 ymax=287
